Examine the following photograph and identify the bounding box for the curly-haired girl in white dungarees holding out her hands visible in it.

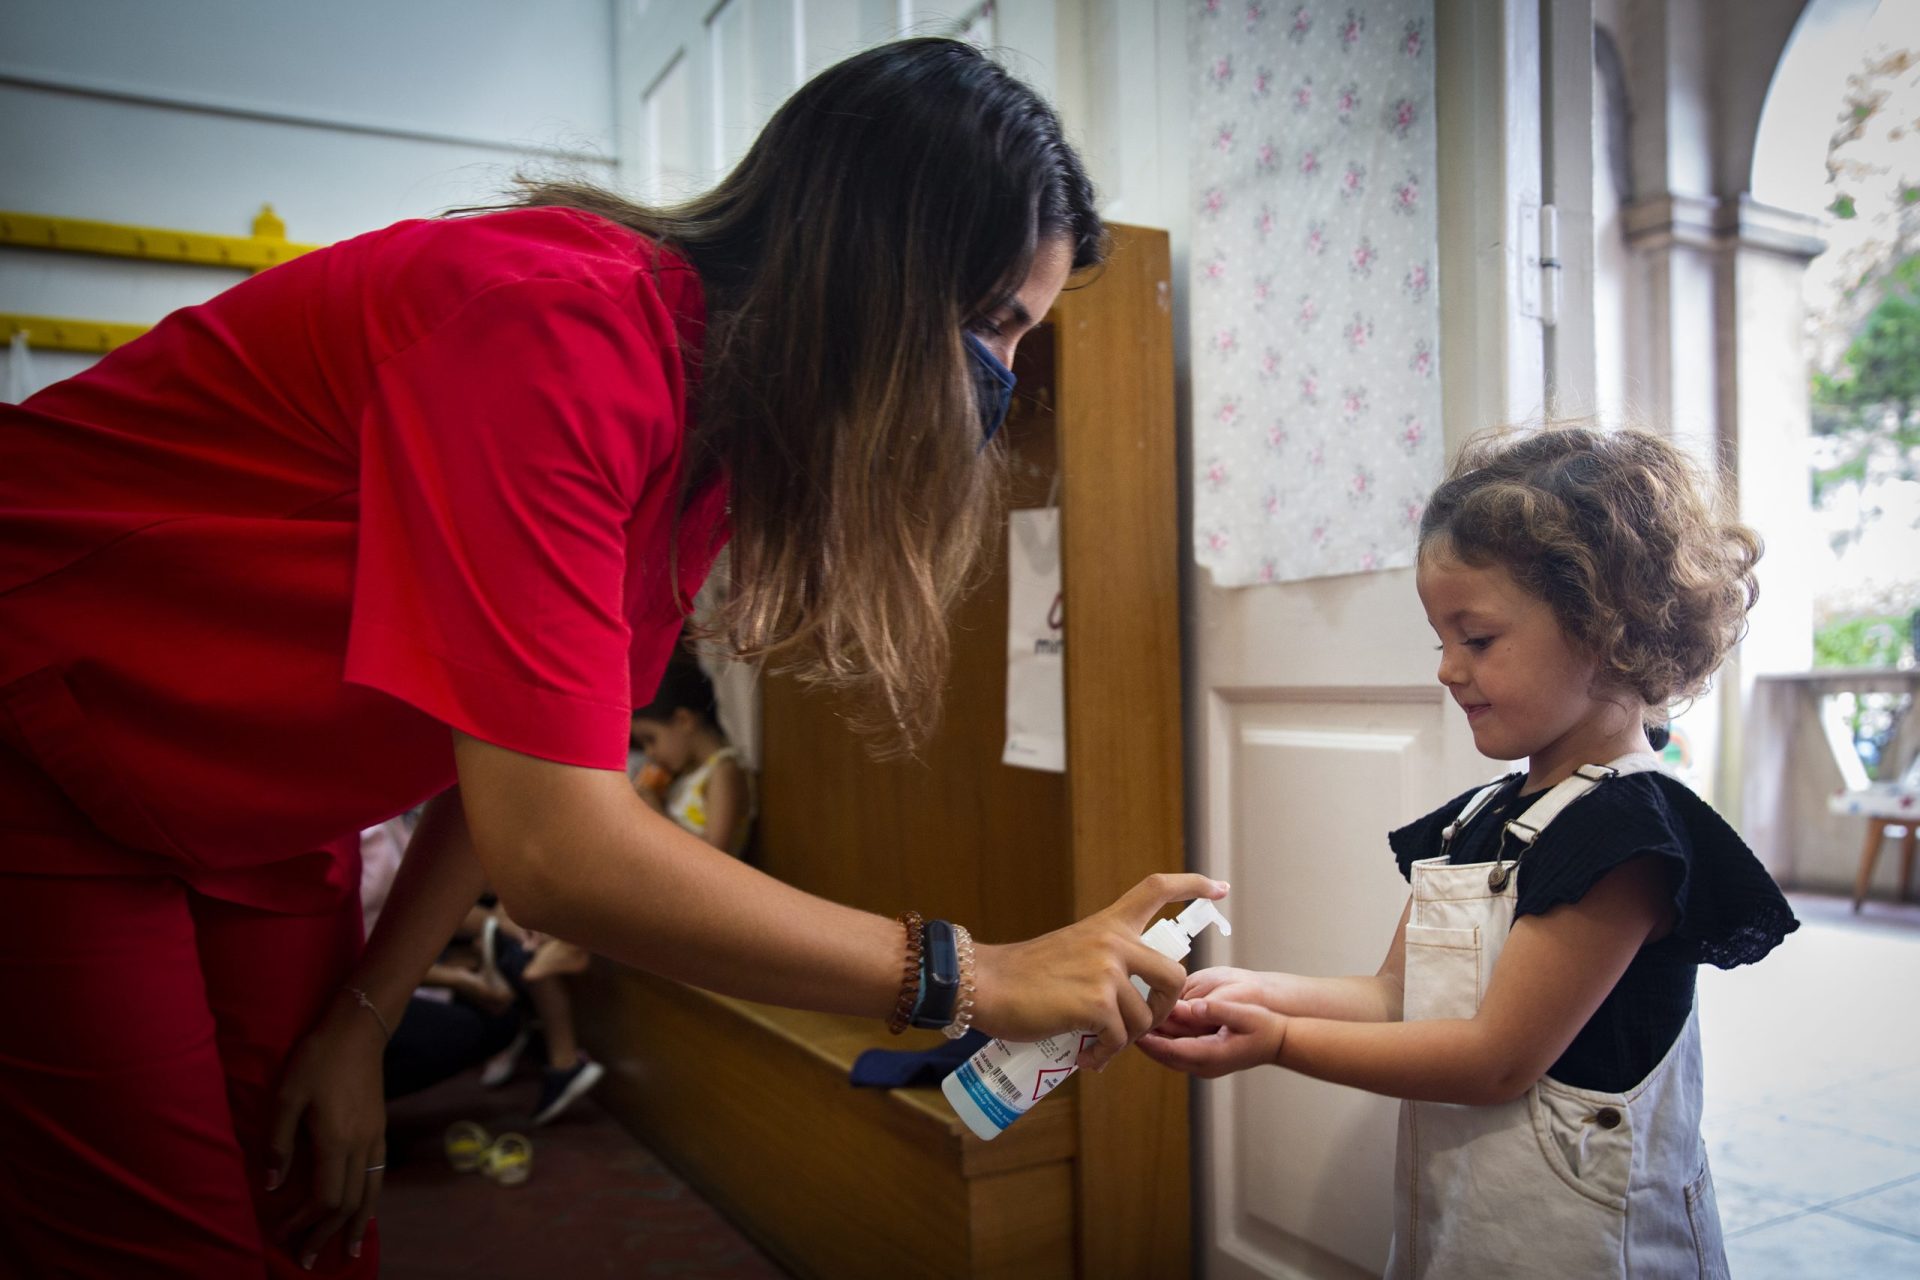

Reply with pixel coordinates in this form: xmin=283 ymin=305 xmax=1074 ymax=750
xmin=1140 ymin=428 xmax=1797 ymax=1278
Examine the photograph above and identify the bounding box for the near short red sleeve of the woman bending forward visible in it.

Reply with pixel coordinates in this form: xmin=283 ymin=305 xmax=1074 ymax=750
xmin=346 ymin=278 xmax=684 ymax=768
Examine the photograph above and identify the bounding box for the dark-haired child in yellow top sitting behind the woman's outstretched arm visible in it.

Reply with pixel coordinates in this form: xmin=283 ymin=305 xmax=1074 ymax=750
xmin=634 ymin=654 xmax=755 ymax=858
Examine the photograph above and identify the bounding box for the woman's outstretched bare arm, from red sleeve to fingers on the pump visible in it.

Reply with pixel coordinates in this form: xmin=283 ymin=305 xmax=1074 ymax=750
xmin=453 ymin=733 xmax=1227 ymax=1063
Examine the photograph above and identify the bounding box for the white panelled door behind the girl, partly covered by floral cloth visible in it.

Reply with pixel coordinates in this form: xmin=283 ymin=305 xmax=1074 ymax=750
xmin=1182 ymin=0 xmax=1592 ymax=1280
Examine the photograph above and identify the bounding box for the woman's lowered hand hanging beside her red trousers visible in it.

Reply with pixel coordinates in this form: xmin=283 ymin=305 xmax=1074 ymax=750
xmin=267 ymin=994 xmax=386 ymax=1268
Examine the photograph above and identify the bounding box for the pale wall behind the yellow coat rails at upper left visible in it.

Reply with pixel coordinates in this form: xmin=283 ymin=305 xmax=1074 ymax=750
xmin=0 ymin=0 xmax=614 ymax=395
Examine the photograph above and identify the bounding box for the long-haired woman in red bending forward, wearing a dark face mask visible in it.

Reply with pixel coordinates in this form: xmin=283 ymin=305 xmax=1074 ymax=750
xmin=0 ymin=40 xmax=1223 ymax=1276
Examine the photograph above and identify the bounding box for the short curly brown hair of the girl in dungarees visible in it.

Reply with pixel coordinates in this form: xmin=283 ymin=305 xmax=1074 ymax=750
xmin=1421 ymin=426 xmax=1761 ymax=723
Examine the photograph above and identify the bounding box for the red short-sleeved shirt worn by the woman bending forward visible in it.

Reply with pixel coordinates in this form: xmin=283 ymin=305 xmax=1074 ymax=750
xmin=0 ymin=209 xmax=724 ymax=890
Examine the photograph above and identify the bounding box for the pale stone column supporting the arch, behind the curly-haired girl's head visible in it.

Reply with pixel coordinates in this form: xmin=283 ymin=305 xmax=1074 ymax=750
xmin=1596 ymin=0 xmax=1853 ymax=844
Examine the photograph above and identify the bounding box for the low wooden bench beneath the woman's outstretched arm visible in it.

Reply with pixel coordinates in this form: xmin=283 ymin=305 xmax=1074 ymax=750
xmin=578 ymin=961 xmax=1075 ymax=1280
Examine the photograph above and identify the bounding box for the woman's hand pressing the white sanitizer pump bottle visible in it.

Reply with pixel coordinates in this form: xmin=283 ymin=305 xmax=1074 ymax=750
xmin=973 ymin=875 xmax=1227 ymax=1069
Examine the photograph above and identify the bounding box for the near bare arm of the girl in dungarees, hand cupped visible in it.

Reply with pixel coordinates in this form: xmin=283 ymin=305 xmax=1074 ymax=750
xmin=1140 ymin=858 xmax=1668 ymax=1105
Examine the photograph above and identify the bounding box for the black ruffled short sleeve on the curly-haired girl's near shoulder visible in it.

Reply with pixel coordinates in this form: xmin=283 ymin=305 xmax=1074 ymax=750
xmin=1515 ymin=771 xmax=1799 ymax=969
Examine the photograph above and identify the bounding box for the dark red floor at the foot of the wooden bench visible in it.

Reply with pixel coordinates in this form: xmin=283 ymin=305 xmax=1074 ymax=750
xmin=378 ymin=1073 xmax=783 ymax=1280
